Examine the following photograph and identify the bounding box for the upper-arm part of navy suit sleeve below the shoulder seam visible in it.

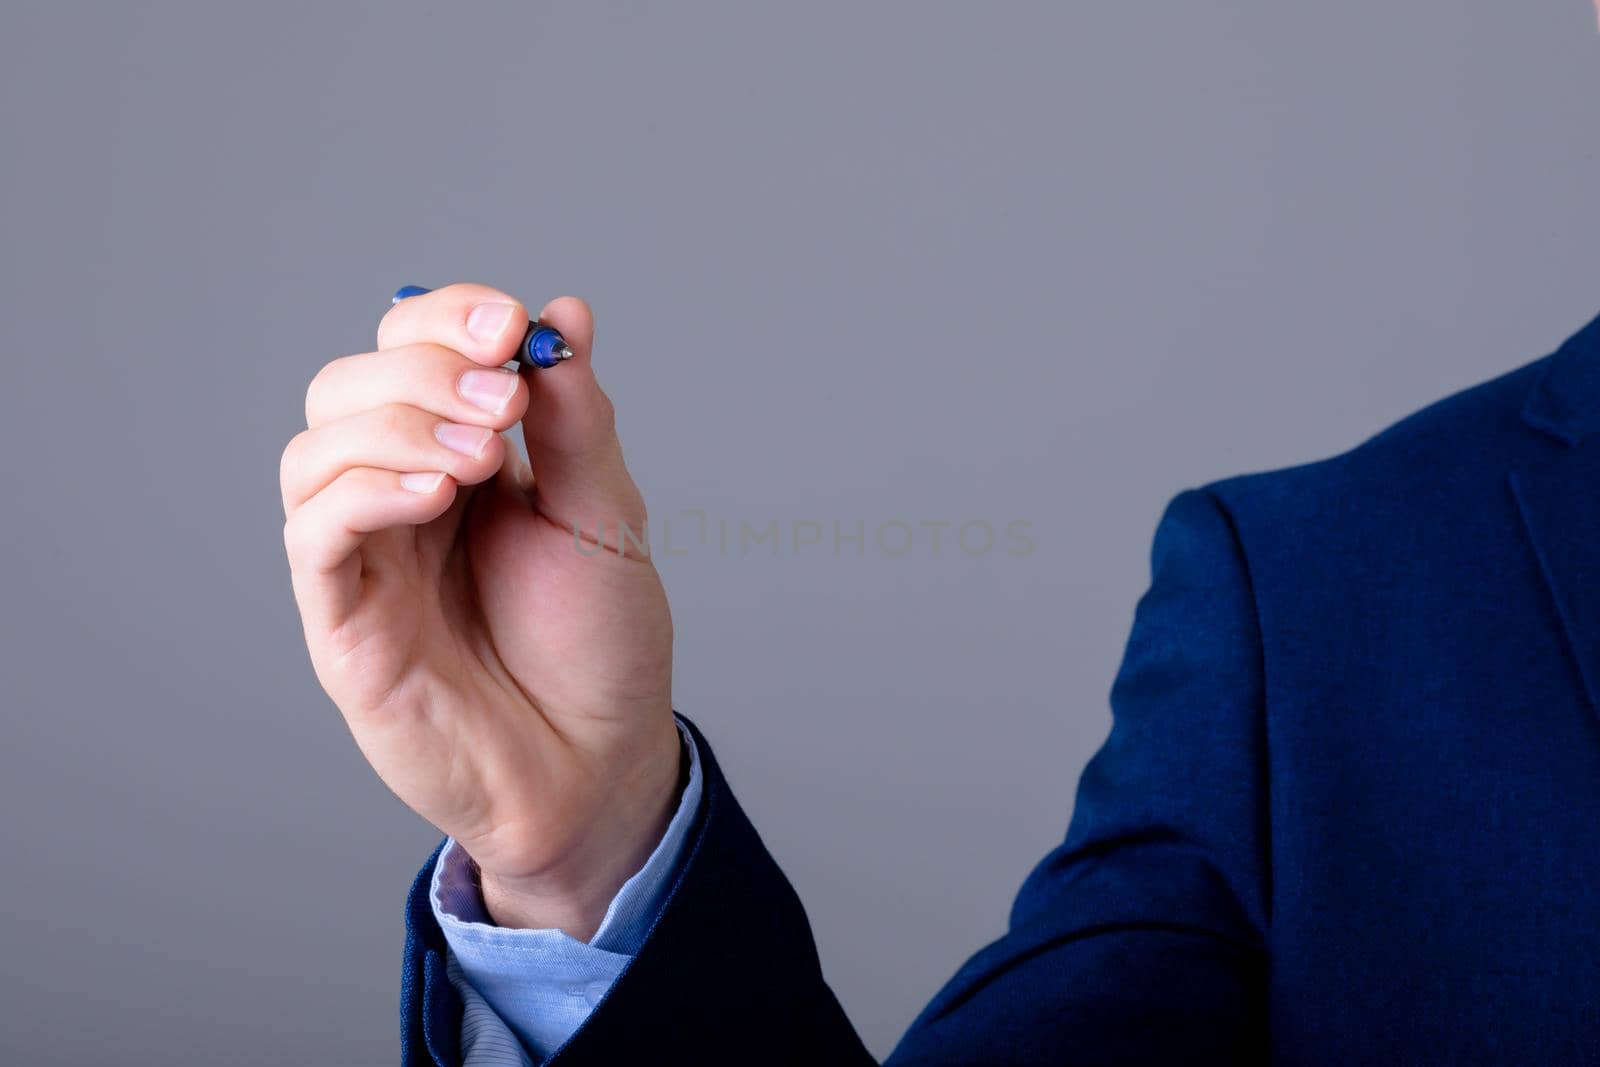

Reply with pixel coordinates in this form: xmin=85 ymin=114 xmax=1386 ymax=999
xmin=890 ymin=490 xmax=1267 ymax=1067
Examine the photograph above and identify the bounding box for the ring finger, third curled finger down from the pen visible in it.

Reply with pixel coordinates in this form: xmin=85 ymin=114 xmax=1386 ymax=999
xmin=280 ymin=403 xmax=506 ymax=514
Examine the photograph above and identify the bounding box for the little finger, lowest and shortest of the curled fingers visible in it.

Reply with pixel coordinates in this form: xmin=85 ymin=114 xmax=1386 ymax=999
xmin=283 ymin=467 xmax=456 ymax=582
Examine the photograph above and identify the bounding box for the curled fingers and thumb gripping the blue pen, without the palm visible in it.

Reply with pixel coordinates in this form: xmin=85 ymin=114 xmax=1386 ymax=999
xmin=294 ymin=285 xmax=645 ymax=585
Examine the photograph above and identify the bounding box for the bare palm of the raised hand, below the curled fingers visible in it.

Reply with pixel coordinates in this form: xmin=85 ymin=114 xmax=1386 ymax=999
xmin=325 ymin=467 xmax=672 ymax=869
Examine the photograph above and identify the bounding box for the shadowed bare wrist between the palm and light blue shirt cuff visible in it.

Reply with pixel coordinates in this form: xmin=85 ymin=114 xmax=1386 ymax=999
xmin=478 ymin=721 xmax=690 ymax=942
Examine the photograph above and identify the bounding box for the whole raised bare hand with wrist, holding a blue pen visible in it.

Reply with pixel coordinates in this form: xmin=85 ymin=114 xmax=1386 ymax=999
xmin=282 ymin=285 xmax=680 ymax=941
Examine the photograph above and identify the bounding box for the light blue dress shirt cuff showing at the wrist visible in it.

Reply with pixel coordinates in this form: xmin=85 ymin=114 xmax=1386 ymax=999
xmin=430 ymin=723 xmax=701 ymax=1067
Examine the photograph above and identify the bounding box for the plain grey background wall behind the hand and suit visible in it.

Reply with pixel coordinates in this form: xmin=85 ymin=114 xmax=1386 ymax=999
xmin=0 ymin=0 xmax=1600 ymax=1064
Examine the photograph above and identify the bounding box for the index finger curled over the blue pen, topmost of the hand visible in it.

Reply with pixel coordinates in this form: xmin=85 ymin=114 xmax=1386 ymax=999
xmin=378 ymin=283 xmax=528 ymax=366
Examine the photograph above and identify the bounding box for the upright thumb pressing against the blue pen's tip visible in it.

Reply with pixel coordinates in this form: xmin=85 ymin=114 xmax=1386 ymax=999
xmin=522 ymin=296 xmax=645 ymax=547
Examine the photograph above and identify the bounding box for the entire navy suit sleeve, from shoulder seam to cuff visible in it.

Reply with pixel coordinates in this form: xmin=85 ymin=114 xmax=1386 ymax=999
xmin=402 ymin=490 xmax=1266 ymax=1067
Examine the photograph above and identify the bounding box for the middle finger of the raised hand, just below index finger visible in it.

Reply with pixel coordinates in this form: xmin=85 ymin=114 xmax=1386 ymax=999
xmin=306 ymin=342 xmax=528 ymax=430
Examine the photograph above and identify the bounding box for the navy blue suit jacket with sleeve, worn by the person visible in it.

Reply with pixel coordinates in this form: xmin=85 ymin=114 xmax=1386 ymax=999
xmin=402 ymin=313 xmax=1600 ymax=1067
